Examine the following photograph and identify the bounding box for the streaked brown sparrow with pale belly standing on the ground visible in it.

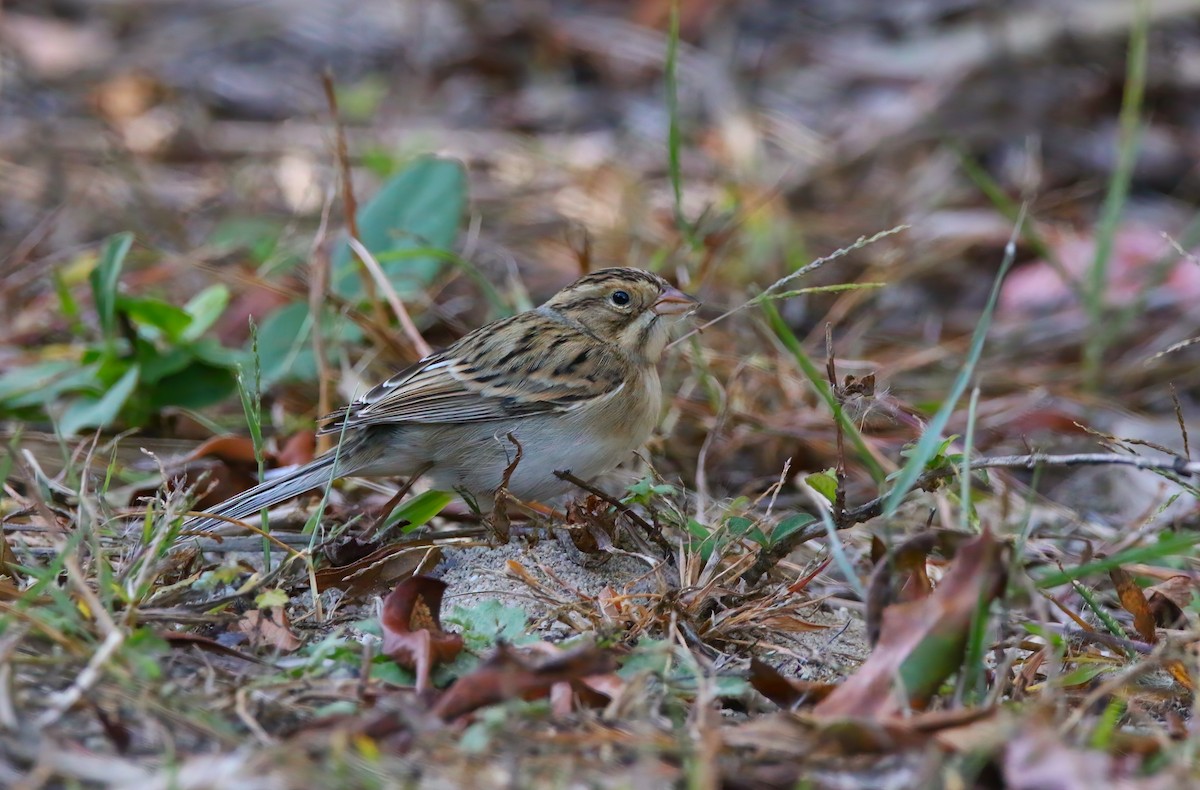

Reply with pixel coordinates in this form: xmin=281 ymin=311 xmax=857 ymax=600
xmin=185 ymin=268 xmax=700 ymax=531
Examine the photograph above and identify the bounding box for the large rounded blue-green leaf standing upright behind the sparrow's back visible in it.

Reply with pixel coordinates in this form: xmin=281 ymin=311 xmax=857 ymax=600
xmin=332 ymin=156 xmax=467 ymax=299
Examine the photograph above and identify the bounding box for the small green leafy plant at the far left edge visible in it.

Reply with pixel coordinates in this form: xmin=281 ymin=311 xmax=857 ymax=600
xmin=0 ymin=233 xmax=241 ymax=436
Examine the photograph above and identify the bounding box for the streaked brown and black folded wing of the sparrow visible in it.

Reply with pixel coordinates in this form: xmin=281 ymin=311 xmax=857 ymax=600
xmin=322 ymin=312 xmax=632 ymax=433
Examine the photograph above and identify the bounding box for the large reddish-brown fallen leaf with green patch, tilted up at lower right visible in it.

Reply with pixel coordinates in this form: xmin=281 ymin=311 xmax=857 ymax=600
xmin=814 ymin=531 xmax=1007 ymax=719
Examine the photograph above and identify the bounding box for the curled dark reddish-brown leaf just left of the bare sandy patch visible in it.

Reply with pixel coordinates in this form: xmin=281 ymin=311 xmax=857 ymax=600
xmin=379 ymin=576 xmax=462 ymax=692
